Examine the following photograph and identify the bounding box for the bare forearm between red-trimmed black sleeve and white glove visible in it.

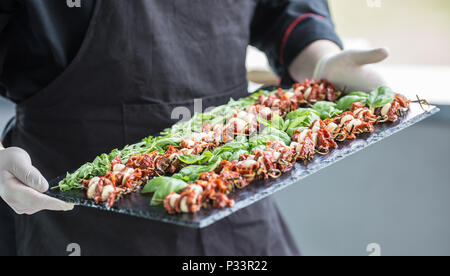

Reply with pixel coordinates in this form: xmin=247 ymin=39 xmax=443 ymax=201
xmin=289 ymin=40 xmax=341 ymax=82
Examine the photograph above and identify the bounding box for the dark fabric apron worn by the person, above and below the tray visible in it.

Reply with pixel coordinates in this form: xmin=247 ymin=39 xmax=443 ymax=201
xmin=3 ymin=0 xmax=298 ymax=255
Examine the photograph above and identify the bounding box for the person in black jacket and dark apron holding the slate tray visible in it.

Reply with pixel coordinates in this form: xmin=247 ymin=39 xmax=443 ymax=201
xmin=0 ymin=0 xmax=388 ymax=255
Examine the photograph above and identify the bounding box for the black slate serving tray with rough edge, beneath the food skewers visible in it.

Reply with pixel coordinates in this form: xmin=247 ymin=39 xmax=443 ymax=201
xmin=47 ymin=103 xmax=439 ymax=228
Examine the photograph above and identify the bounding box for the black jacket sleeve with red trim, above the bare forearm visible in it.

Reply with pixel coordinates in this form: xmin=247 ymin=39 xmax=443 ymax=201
xmin=250 ymin=0 xmax=342 ymax=77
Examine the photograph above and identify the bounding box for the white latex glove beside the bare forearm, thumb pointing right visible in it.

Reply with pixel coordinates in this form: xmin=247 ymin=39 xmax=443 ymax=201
xmin=314 ymin=48 xmax=389 ymax=92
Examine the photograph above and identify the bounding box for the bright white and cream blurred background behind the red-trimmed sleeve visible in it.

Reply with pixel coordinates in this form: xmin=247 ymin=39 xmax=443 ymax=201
xmin=247 ymin=0 xmax=450 ymax=104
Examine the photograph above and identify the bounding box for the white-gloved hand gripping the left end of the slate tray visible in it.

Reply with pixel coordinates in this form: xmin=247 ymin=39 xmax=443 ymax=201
xmin=0 ymin=144 xmax=74 ymax=215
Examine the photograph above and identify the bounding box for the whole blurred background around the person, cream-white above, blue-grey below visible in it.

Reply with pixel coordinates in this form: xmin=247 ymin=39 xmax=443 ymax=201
xmin=0 ymin=0 xmax=450 ymax=255
